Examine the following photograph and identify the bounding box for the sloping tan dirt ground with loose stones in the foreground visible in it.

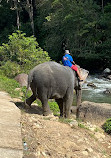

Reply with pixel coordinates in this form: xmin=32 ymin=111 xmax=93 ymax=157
xmin=16 ymin=102 xmax=111 ymax=158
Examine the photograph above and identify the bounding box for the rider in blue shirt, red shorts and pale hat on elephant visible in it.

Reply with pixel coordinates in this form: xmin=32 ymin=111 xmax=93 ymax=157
xmin=62 ymin=50 xmax=83 ymax=82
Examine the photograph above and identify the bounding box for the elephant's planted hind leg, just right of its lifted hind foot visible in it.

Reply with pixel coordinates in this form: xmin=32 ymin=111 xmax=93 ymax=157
xmin=41 ymin=98 xmax=52 ymax=116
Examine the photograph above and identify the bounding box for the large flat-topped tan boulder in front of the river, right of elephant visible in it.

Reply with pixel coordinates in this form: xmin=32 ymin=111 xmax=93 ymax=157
xmin=77 ymin=101 xmax=111 ymax=125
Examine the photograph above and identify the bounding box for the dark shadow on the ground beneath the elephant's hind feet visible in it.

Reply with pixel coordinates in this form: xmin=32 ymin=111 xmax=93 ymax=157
xmin=13 ymin=102 xmax=43 ymax=115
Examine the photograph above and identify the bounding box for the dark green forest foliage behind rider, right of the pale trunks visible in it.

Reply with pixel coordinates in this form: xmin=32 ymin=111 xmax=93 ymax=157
xmin=37 ymin=0 xmax=111 ymax=69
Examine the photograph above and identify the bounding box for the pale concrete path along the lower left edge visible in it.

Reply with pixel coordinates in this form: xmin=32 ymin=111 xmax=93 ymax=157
xmin=0 ymin=93 xmax=23 ymax=158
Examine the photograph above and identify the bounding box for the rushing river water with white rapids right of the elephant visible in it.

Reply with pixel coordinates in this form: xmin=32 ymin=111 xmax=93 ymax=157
xmin=82 ymin=75 xmax=111 ymax=104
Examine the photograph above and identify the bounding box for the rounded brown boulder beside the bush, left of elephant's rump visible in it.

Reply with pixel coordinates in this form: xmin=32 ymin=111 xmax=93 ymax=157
xmin=15 ymin=73 xmax=28 ymax=87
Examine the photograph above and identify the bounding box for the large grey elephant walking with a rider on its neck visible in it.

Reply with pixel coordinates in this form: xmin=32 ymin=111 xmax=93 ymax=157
xmin=25 ymin=61 xmax=88 ymax=118
